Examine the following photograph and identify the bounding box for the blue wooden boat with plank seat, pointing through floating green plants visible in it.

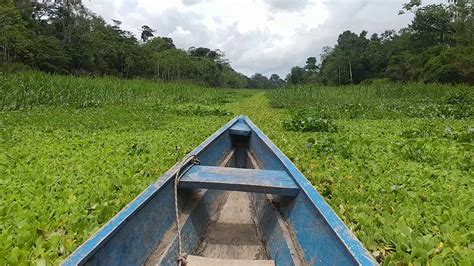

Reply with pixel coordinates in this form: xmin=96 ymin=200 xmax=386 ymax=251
xmin=63 ymin=116 xmax=377 ymax=266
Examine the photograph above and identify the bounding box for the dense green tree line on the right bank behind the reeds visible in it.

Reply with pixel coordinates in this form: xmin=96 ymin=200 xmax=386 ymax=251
xmin=286 ymin=0 xmax=474 ymax=85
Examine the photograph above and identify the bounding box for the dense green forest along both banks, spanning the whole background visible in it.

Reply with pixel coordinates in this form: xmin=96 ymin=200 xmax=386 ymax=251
xmin=0 ymin=0 xmax=474 ymax=88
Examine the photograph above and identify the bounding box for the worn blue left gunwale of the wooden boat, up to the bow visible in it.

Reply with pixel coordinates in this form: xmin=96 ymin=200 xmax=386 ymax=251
xmin=62 ymin=116 xmax=241 ymax=265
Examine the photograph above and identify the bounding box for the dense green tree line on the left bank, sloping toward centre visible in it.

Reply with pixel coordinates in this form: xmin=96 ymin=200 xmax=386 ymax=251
xmin=0 ymin=0 xmax=249 ymax=88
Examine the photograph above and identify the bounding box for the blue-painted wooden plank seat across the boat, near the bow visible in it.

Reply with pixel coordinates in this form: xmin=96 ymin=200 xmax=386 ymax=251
xmin=179 ymin=165 xmax=300 ymax=196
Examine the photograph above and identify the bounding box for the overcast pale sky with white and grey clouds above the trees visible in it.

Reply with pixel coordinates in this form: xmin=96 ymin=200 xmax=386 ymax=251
xmin=83 ymin=0 xmax=434 ymax=77
